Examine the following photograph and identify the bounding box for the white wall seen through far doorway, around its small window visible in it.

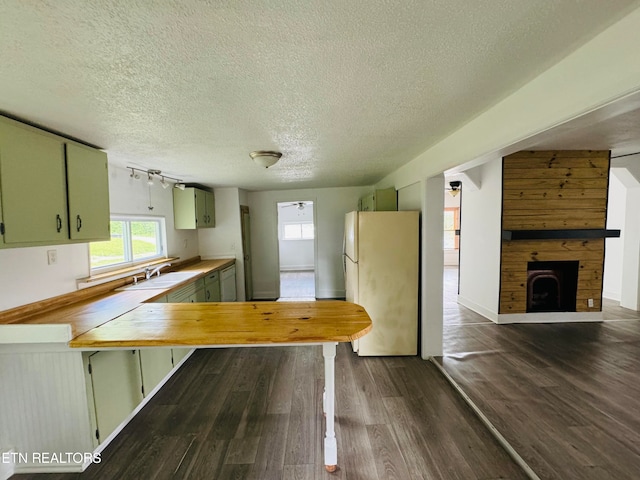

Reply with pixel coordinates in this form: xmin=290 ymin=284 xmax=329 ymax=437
xmin=278 ymin=199 xmax=315 ymax=271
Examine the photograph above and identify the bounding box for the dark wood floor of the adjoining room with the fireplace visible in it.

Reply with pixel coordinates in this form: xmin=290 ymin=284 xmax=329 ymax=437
xmin=441 ymin=266 xmax=640 ymax=480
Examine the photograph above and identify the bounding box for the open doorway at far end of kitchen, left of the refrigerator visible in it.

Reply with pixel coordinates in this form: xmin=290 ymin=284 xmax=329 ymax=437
xmin=278 ymin=200 xmax=316 ymax=301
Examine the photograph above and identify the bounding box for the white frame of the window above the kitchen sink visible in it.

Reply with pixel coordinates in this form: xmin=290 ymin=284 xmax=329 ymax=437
xmin=89 ymin=214 xmax=167 ymax=274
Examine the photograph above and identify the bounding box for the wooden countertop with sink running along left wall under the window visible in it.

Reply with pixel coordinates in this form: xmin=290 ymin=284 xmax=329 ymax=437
xmin=0 ymin=259 xmax=235 ymax=338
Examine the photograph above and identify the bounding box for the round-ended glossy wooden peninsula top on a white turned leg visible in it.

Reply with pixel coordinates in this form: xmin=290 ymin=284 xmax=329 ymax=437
xmin=69 ymin=300 xmax=371 ymax=349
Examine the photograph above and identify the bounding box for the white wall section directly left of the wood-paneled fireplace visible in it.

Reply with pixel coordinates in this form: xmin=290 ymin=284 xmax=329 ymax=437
xmin=458 ymin=158 xmax=502 ymax=321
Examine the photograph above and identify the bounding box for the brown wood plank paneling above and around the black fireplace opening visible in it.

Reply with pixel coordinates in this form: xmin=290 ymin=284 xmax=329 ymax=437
xmin=499 ymin=150 xmax=609 ymax=314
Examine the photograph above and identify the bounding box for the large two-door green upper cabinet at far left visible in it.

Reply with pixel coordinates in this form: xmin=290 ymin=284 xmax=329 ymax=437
xmin=0 ymin=117 xmax=110 ymax=248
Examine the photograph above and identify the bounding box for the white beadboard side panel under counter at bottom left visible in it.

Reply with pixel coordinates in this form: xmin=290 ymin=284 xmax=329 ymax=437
xmin=0 ymin=352 xmax=93 ymax=473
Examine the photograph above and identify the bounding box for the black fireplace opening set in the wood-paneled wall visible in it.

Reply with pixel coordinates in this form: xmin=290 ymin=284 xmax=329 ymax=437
xmin=527 ymin=260 xmax=580 ymax=313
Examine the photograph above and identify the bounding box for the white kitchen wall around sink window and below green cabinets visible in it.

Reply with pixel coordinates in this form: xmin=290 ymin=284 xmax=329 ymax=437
xmin=0 ymin=166 xmax=198 ymax=310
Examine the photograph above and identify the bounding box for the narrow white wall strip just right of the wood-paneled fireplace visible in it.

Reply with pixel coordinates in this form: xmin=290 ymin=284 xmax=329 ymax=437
xmin=602 ymin=169 xmax=627 ymax=302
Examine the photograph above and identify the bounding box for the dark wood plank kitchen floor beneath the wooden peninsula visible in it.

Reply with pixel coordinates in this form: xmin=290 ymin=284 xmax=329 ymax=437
xmin=13 ymin=344 xmax=526 ymax=480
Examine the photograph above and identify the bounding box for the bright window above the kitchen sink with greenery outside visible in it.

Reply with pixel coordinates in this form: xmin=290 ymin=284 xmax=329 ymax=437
xmin=89 ymin=217 xmax=165 ymax=270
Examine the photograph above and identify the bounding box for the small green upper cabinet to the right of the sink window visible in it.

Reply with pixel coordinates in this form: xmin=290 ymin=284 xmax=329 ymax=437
xmin=173 ymin=187 xmax=216 ymax=229
